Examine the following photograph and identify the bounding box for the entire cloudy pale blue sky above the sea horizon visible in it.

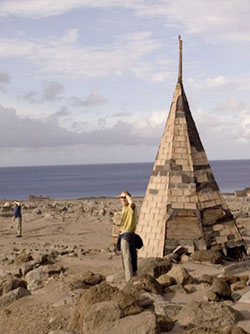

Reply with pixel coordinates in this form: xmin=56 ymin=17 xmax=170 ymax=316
xmin=0 ymin=0 xmax=250 ymax=167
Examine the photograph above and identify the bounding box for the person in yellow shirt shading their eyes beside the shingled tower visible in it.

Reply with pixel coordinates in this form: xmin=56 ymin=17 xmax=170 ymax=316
xmin=117 ymin=190 xmax=137 ymax=281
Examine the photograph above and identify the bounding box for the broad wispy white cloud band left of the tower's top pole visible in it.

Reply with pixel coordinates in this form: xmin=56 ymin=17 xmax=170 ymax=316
xmin=0 ymin=32 xmax=166 ymax=80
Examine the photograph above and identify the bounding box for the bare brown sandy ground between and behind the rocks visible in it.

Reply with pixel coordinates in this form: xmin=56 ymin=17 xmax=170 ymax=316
xmin=0 ymin=196 xmax=250 ymax=334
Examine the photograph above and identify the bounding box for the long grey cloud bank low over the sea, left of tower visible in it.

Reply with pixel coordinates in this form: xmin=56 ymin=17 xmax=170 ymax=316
xmin=0 ymin=105 xmax=166 ymax=147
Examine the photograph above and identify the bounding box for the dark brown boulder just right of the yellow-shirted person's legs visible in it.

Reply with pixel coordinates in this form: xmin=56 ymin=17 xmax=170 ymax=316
xmin=139 ymin=257 xmax=172 ymax=278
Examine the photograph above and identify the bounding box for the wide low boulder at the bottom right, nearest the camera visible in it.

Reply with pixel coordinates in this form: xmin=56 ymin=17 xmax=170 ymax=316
xmin=176 ymin=302 xmax=241 ymax=328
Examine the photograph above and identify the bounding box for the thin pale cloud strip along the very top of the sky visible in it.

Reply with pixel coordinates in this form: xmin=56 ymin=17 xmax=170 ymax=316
xmin=0 ymin=0 xmax=250 ymax=41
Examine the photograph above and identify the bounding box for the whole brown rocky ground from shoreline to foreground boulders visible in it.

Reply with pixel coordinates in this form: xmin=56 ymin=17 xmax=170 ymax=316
xmin=0 ymin=195 xmax=250 ymax=334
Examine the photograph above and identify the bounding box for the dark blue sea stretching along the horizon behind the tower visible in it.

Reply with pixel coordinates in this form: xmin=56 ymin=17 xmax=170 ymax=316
xmin=0 ymin=160 xmax=250 ymax=200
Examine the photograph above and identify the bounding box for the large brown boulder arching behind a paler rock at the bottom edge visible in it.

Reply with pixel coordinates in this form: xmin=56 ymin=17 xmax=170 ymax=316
xmin=69 ymin=282 xmax=143 ymax=334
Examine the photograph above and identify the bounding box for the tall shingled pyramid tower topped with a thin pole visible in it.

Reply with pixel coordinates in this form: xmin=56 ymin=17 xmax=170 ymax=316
xmin=137 ymin=36 xmax=245 ymax=257
